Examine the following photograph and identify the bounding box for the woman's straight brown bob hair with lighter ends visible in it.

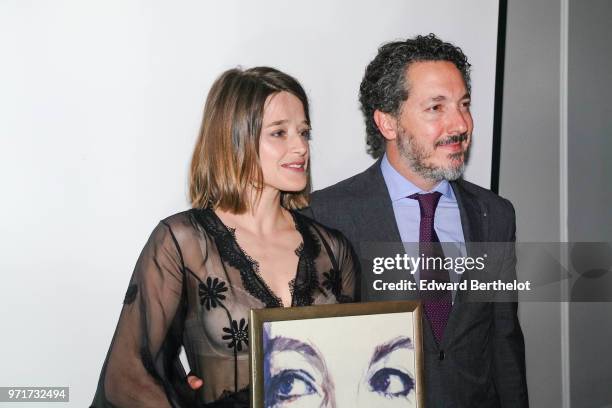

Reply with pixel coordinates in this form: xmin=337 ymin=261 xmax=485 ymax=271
xmin=189 ymin=67 xmax=311 ymax=214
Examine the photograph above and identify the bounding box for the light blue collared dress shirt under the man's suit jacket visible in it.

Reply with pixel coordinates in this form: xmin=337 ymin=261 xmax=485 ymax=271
xmin=380 ymin=154 xmax=466 ymax=298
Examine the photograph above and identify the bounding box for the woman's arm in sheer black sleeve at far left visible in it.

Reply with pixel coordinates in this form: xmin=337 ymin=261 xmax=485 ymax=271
xmin=92 ymin=221 xmax=191 ymax=408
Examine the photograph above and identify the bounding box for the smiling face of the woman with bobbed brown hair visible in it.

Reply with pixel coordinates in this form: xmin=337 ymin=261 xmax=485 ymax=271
xmin=259 ymin=92 xmax=310 ymax=192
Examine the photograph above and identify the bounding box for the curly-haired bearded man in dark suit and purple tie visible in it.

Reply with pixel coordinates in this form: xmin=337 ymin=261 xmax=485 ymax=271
xmin=311 ymin=34 xmax=528 ymax=408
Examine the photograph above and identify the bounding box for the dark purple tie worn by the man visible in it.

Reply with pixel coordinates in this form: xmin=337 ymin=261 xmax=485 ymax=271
xmin=408 ymin=191 xmax=452 ymax=344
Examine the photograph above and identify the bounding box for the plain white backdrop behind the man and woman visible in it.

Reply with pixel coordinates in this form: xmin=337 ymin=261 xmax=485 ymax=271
xmin=0 ymin=0 xmax=498 ymax=407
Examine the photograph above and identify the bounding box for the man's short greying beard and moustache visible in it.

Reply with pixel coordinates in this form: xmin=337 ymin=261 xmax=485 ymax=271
xmin=396 ymin=128 xmax=468 ymax=181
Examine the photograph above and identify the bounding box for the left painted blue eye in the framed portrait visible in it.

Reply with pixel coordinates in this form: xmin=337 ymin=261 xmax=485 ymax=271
xmin=266 ymin=370 xmax=317 ymax=406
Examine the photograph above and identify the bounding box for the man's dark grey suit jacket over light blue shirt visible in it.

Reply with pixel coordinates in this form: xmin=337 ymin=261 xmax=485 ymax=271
xmin=305 ymin=160 xmax=528 ymax=408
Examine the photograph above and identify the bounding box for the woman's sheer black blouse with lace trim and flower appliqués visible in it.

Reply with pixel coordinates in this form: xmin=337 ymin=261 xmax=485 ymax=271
xmin=92 ymin=209 xmax=358 ymax=408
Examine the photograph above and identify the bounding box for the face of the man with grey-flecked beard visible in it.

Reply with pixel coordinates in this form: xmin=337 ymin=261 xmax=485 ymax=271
xmin=395 ymin=61 xmax=474 ymax=181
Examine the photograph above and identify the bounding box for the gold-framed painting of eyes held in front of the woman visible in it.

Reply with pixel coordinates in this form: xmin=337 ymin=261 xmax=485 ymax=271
xmin=249 ymin=301 xmax=424 ymax=408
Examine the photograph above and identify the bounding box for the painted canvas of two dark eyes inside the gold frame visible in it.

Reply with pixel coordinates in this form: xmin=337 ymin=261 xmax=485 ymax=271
xmin=264 ymin=313 xmax=416 ymax=408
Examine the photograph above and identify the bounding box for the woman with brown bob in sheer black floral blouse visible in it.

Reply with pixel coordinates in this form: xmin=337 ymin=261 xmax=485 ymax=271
xmin=93 ymin=67 xmax=357 ymax=408
